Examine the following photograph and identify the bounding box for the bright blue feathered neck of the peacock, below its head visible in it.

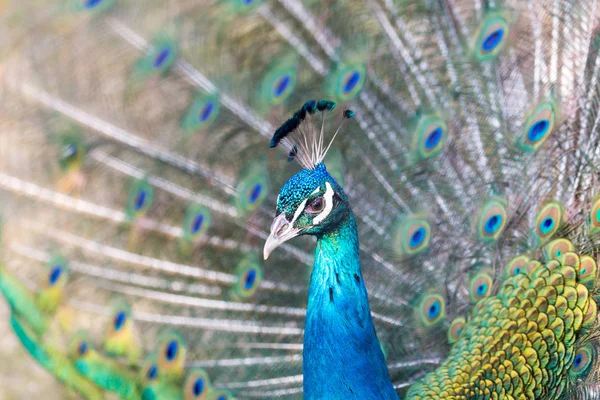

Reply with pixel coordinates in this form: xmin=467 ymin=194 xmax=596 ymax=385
xmin=303 ymin=213 xmax=398 ymax=400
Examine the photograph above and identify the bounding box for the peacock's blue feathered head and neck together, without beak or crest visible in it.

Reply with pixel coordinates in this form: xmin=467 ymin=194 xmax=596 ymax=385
xmin=272 ymin=164 xmax=398 ymax=399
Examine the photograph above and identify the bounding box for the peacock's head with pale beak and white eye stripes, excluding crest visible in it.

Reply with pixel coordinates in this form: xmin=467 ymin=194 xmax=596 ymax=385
xmin=264 ymin=163 xmax=350 ymax=260
